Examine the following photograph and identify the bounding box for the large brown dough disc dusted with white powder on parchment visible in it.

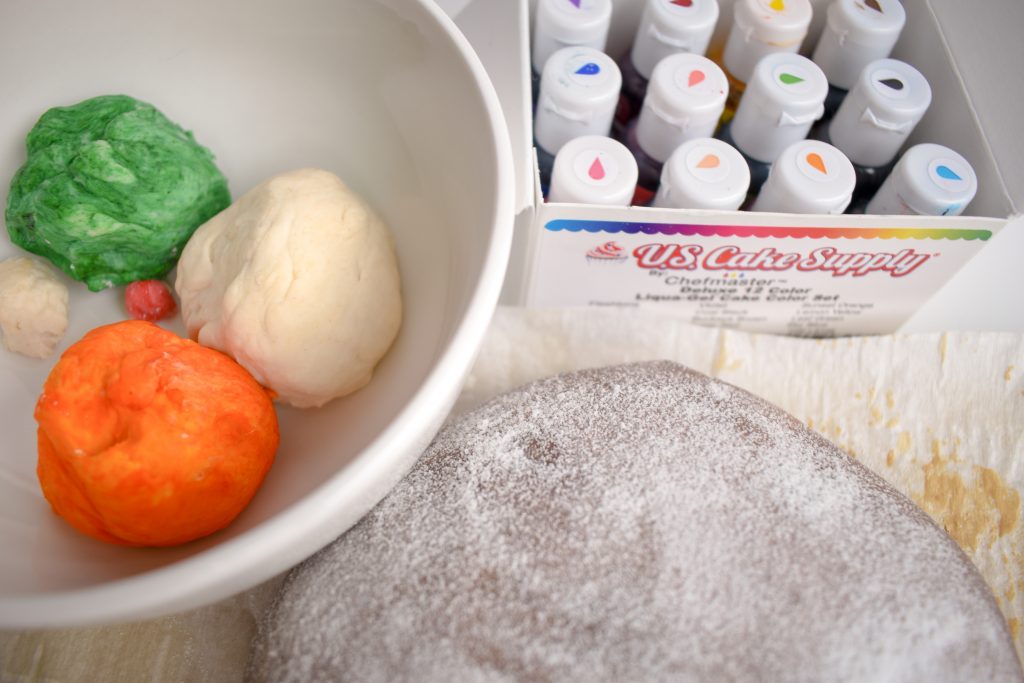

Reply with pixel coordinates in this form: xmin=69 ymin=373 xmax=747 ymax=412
xmin=248 ymin=362 xmax=1022 ymax=682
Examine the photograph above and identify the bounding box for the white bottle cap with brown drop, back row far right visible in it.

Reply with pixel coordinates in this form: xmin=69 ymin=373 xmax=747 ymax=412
xmin=813 ymin=0 xmax=906 ymax=90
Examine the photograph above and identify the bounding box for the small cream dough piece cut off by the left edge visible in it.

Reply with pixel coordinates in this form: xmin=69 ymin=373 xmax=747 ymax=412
xmin=0 ymin=256 xmax=68 ymax=358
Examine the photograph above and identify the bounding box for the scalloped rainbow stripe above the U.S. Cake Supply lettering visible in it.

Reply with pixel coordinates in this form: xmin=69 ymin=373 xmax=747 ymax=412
xmin=544 ymin=218 xmax=992 ymax=242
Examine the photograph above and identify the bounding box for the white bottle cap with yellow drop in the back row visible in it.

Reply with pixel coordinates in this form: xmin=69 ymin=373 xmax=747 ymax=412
xmin=722 ymin=0 xmax=811 ymax=83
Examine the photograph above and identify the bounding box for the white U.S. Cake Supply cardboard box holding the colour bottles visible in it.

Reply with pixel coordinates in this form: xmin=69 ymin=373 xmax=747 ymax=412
xmin=452 ymin=0 xmax=1024 ymax=336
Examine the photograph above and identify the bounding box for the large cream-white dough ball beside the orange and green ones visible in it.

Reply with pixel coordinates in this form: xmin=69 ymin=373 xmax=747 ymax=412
xmin=174 ymin=169 xmax=401 ymax=408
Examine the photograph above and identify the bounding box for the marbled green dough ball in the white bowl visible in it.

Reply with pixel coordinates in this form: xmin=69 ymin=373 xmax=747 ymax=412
xmin=5 ymin=95 xmax=231 ymax=292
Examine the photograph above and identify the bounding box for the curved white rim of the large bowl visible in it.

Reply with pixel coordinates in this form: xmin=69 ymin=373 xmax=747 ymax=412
xmin=0 ymin=0 xmax=515 ymax=629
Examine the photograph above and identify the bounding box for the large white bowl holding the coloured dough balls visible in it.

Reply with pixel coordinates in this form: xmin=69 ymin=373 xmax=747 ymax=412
xmin=0 ymin=0 xmax=514 ymax=628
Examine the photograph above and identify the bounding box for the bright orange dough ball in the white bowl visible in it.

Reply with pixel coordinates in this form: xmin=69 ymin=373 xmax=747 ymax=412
xmin=36 ymin=321 xmax=280 ymax=546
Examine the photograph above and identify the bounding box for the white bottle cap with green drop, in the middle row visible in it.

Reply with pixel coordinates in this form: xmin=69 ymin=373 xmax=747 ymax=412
xmin=730 ymin=52 xmax=828 ymax=164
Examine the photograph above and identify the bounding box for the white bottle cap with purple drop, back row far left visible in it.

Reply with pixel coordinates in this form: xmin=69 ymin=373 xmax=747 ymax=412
xmin=531 ymin=0 xmax=611 ymax=74
